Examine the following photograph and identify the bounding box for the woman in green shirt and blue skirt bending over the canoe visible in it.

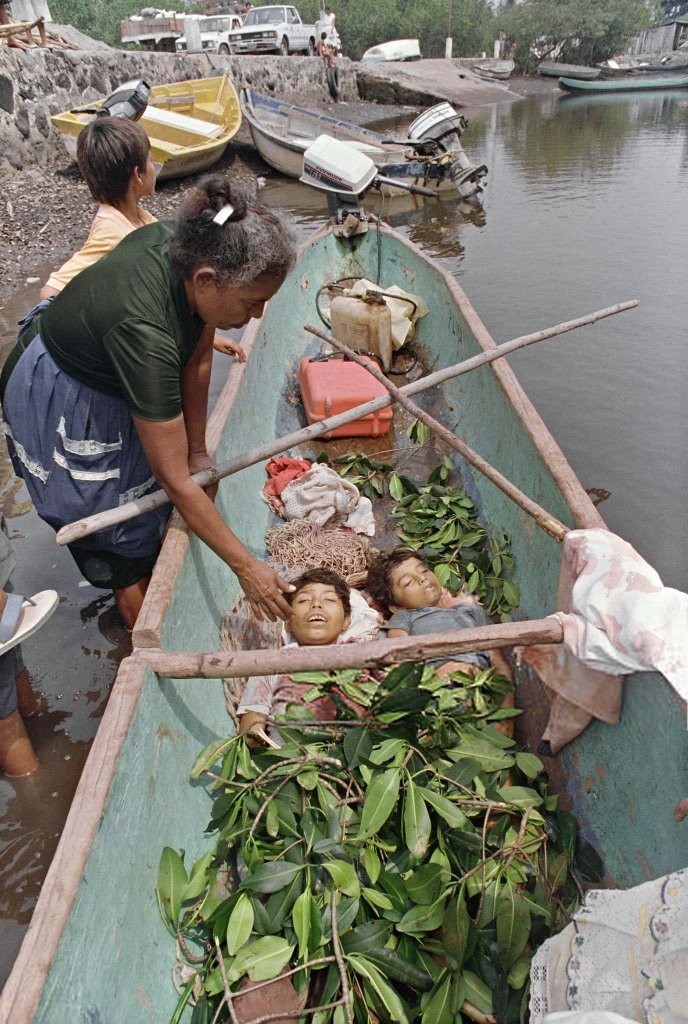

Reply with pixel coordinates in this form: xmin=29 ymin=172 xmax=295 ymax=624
xmin=0 ymin=175 xmax=295 ymax=628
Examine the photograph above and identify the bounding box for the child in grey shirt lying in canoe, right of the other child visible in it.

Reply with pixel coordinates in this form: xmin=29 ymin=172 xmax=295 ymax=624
xmin=367 ymin=548 xmax=508 ymax=676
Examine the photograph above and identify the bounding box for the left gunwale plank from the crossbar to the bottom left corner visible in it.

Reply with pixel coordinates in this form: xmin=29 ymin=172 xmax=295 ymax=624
xmin=0 ymin=657 xmax=145 ymax=1024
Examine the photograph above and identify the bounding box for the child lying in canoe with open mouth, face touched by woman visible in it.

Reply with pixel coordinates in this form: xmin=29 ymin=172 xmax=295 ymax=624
xmin=237 ymin=568 xmax=380 ymax=741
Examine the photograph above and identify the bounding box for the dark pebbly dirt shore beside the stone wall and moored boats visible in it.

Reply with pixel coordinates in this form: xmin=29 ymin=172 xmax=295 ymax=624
xmin=0 ymin=78 xmax=557 ymax=309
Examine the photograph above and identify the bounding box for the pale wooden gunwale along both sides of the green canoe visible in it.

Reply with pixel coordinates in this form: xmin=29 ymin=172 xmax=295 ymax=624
xmin=0 ymin=224 xmax=605 ymax=1024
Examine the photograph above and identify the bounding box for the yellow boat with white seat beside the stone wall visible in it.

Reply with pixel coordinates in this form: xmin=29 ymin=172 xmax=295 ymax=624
xmin=50 ymin=75 xmax=242 ymax=181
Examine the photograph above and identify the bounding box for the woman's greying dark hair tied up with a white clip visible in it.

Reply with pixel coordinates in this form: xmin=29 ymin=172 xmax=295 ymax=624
xmin=170 ymin=174 xmax=296 ymax=288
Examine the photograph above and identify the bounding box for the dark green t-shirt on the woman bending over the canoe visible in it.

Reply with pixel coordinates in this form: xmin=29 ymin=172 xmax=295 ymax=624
xmin=40 ymin=221 xmax=203 ymax=420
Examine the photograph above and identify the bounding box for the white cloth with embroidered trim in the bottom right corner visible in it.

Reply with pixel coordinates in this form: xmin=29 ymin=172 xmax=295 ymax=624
xmin=530 ymin=869 xmax=688 ymax=1024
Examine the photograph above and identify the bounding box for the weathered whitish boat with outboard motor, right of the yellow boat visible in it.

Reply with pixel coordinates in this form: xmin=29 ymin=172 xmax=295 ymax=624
xmin=241 ymin=88 xmax=487 ymax=198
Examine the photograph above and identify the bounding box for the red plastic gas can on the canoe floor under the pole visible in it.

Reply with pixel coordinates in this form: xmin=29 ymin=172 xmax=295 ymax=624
xmin=299 ymin=358 xmax=393 ymax=437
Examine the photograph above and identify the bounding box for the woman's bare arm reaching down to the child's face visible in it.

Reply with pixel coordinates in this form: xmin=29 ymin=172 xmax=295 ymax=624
xmin=133 ymin=411 xmax=293 ymax=621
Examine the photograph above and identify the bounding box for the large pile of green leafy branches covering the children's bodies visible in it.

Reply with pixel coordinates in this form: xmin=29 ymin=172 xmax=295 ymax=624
xmin=157 ymin=665 xmax=597 ymax=1024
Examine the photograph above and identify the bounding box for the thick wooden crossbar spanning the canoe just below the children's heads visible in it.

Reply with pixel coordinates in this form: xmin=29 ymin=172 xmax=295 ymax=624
xmin=134 ymin=616 xmax=564 ymax=679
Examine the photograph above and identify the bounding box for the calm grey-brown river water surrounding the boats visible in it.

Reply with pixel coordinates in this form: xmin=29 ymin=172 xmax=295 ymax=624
xmin=0 ymin=90 xmax=688 ymax=985
